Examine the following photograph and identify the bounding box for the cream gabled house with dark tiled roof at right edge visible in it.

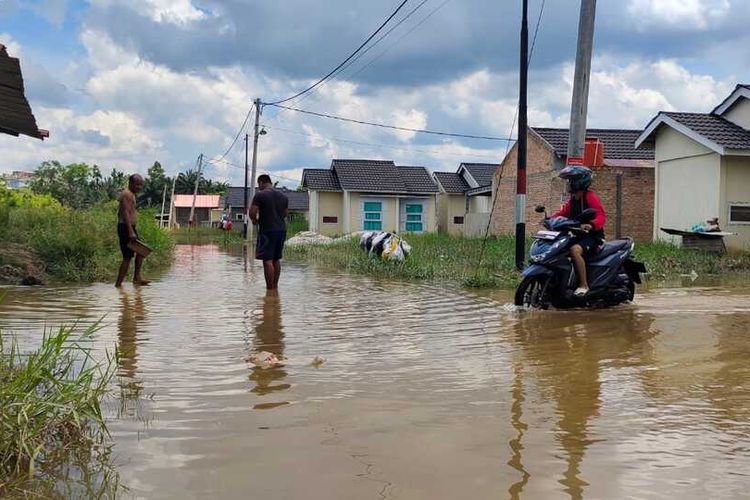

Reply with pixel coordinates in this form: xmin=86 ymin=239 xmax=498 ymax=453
xmin=635 ymin=84 xmax=750 ymax=250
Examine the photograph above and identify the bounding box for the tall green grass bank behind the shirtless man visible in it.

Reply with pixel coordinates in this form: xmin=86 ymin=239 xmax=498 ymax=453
xmin=0 ymin=199 xmax=174 ymax=282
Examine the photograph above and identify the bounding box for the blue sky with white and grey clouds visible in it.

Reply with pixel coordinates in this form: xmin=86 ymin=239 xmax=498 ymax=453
xmin=0 ymin=0 xmax=750 ymax=185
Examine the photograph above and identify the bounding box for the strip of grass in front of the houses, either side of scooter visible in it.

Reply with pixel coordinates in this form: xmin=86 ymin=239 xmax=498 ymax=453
xmin=285 ymin=234 xmax=750 ymax=287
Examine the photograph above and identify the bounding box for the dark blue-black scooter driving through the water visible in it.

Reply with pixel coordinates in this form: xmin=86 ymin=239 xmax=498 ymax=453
xmin=515 ymin=205 xmax=646 ymax=309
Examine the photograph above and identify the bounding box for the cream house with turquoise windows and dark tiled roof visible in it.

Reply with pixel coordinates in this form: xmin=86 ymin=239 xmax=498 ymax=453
xmin=302 ymin=159 xmax=438 ymax=236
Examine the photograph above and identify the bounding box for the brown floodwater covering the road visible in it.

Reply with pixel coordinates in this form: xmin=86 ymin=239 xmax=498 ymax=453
xmin=0 ymin=246 xmax=750 ymax=499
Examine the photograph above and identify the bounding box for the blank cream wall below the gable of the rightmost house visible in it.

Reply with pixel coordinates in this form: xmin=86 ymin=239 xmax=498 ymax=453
xmin=654 ymin=129 xmax=721 ymax=242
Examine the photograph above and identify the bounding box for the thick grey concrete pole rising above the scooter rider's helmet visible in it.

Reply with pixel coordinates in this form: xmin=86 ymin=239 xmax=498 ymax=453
xmin=568 ymin=0 xmax=596 ymax=164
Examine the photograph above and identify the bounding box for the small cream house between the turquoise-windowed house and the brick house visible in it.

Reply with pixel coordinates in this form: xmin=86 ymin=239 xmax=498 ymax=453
xmin=432 ymin=163 xmax=500 ymax=236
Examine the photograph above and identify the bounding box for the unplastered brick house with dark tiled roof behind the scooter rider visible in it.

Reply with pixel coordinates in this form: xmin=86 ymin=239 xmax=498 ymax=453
xmin=491 ymin=127 xmax=654 ymax=241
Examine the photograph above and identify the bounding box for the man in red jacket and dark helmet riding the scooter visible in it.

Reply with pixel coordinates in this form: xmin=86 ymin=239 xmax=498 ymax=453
xmin=553 ymin=165 xmax=607 ymax=297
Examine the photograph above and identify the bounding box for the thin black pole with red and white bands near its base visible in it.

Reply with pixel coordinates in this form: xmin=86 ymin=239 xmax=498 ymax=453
xmin=516 ymin=0 xmax=529 ymax=270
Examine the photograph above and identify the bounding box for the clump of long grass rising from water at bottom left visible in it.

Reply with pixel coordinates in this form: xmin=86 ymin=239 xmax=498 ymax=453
xmin=0 ymin=327 xmax=119 ymax=498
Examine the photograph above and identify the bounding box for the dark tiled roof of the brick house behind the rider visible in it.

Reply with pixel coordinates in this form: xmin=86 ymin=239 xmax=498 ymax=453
xmin=533 ymin=127 xmax=654 ymax=160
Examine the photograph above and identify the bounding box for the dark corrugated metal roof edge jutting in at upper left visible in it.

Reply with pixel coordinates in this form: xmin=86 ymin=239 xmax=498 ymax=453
xmin=0 ymin=44 xmax=49 ymax=139
